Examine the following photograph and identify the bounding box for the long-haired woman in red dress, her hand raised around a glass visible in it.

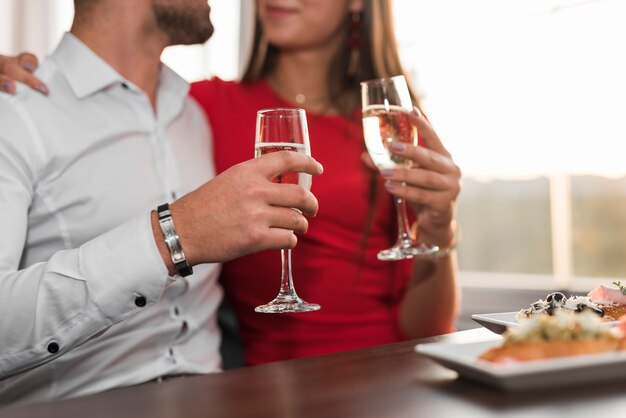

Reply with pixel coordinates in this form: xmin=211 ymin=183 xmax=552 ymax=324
xmin=191 ymin=0 xmax=460 ymax=364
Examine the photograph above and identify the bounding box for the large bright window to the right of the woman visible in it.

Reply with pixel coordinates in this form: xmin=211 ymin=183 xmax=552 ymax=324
xmin=394 ymin=0 xmax=626 ymax=289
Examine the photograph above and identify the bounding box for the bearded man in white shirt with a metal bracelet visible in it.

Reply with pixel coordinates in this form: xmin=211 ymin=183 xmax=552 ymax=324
xmin=0 ymin=0 xmax=322 ymax=404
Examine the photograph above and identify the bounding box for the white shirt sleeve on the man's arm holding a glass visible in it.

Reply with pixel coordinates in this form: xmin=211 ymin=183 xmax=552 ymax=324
xmin=0 ymin=94 xmax=168 ymax=379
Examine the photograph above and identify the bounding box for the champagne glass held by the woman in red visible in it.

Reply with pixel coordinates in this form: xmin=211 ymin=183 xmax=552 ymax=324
xmin=361 ymin=75 xmax=439 ymax=260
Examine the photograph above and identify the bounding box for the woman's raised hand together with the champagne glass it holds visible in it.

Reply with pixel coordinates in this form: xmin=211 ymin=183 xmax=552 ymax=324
xmin=361 ymin=76 xmax=460 ymax=260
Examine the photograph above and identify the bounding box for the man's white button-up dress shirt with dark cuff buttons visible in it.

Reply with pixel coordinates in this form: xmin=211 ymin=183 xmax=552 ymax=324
xmin=0 ymin=34 xmax=222 ymax=404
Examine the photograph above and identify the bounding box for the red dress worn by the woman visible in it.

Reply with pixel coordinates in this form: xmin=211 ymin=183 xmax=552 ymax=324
xmin=191 ymin=79 xmax=412 ymax=364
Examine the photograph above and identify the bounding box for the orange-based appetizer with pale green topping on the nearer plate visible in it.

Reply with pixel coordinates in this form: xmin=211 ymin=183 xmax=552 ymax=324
xmin=479 ymin=309 xmax=626 ymax=363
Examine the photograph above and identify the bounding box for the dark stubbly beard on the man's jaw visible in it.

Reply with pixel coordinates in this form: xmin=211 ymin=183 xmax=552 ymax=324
xmin=154 ymin=2 xmax=213 ymax=45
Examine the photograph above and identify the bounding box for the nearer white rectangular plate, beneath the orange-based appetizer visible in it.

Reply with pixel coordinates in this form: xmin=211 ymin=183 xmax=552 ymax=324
xmin=415 ymin=335 xmax=626 ymax=391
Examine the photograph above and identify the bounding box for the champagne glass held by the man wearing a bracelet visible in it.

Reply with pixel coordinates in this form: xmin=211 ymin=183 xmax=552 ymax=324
xmin=254 ymin=108 xmax=320 ymax=313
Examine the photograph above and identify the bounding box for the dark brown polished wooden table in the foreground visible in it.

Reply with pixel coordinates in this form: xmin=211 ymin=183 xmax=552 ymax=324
xmin=0 ymin=328 xmax=626 ymax=418
